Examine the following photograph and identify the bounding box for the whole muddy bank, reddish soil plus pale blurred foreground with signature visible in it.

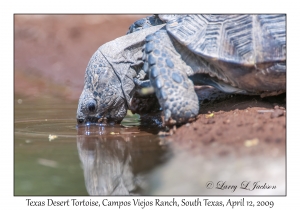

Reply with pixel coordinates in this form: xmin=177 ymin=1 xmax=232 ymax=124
xmin=142 ymin=94 xmax=286 ymax=195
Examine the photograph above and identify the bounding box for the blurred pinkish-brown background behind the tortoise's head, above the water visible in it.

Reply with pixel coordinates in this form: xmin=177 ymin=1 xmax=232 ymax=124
xmin=14 ymin=15 xmax=147 ymax=100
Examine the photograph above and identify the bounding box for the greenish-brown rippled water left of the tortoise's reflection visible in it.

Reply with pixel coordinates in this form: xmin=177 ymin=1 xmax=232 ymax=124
xmin=14 ymin=96 xmax=87 ymax=195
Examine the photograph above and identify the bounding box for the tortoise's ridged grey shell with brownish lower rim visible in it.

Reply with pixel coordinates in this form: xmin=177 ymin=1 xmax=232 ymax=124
xmin=160 ymin=14 xmax=286 ymax=93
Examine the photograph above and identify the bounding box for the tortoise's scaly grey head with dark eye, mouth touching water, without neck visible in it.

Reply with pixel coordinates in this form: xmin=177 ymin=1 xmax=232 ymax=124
xmin=77 ymin=50 xmax=134 ymax=124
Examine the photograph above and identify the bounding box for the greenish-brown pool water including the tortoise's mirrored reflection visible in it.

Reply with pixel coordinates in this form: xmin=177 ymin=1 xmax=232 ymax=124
xmin=14 ymin=95 xmax=166 ymax=195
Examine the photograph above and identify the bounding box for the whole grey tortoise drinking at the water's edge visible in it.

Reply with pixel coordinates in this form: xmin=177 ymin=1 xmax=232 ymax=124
xmin=77 ymin=14 xmax=286 ymax=124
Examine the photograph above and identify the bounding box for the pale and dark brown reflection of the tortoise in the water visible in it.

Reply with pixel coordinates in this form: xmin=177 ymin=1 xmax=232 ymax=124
xmin=77 ymin=125 xmax=168 ymax=195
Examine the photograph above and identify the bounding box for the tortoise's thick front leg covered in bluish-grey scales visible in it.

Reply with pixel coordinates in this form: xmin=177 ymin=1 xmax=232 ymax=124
xmin=143 ymin=30 xmax=199 ymax=124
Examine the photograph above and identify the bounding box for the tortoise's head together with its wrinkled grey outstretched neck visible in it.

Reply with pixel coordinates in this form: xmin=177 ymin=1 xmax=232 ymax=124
xmin=77 ymin=25 xmax=164 ymax=124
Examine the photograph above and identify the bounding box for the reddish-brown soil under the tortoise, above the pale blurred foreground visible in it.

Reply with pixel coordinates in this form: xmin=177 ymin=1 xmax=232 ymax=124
xmin=170 ymin=94 xmax=286 ymax=157
